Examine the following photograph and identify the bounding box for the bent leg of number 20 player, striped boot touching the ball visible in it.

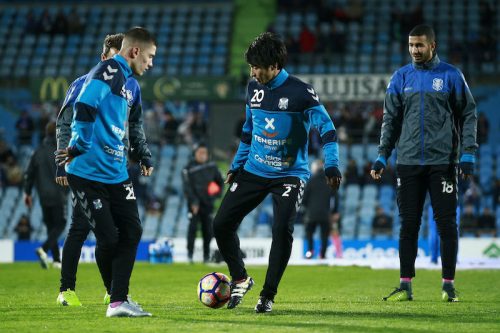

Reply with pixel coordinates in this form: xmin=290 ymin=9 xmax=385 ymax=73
xmin=213 ymin=171 xmax=269 ymax=309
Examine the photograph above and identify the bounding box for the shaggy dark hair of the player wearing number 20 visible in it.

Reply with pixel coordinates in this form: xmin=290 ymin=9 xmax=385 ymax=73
xmin=245 ymin=32 xmax=287 ymax=69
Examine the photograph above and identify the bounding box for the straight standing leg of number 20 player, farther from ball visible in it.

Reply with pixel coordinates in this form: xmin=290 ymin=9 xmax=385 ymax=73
xmin=255 ymin=177 xmax=305 ymax=312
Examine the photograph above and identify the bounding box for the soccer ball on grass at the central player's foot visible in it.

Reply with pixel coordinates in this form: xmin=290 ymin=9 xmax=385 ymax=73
xmin=198 ymin=272 xmax=231 ymax=309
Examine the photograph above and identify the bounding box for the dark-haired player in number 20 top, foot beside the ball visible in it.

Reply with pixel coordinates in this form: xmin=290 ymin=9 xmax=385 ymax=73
xmin=214 ymin=32 xmax=341 ymax=313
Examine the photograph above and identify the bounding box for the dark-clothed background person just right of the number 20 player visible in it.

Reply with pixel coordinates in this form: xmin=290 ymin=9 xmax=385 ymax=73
xmin=301 ymin=160 xmax=338 ymax=259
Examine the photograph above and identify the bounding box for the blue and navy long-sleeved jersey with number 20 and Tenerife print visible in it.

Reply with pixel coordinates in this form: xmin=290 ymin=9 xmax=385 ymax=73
xmin=231 ymin=69 xmax=339 ymax=180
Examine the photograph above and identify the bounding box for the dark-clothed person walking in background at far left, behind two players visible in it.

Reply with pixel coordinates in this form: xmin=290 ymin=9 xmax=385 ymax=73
xmin=24 ymin=122 xmax=68 ymax=269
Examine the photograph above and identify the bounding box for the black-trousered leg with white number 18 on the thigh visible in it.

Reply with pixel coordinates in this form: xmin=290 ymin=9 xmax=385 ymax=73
xmin=429 ymin=165 xmax=458 ymax=302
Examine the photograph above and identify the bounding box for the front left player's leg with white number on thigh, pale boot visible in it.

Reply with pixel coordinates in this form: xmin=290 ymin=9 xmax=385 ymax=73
xmin=106 ymin=180 xmax=151 ymax=317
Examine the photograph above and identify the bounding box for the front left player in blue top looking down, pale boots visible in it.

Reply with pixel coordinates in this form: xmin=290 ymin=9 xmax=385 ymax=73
xmin=56 ymin=27 xmax=156 ymax=317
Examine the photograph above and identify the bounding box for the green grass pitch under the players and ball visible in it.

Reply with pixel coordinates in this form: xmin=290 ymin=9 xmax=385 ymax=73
xmin=0 ymin=263 xmax=500 ymax=333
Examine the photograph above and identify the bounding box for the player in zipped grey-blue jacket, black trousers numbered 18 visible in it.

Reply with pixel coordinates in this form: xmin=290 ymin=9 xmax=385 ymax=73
xmin=370 ymin=25 xmax=477 ymax=302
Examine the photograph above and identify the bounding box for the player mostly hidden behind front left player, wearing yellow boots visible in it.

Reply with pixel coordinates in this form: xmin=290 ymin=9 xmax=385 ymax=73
xmin=56 ymin=34 xmax=153 ymax=306
